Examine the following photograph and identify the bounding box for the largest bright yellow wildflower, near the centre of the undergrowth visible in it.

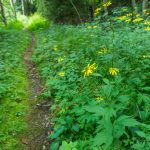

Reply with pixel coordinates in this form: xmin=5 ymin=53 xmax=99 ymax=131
xmin=82 ymin=63 xmax=97 ymax=78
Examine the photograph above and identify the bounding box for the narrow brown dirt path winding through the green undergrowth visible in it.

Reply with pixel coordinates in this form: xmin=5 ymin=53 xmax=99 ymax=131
xmin=21 ymin=34 xmax=50 ymax=150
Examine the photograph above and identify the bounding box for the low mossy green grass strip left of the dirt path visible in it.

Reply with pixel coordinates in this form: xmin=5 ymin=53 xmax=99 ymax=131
xmin=0 ymin=29 xmax=29 ymax=150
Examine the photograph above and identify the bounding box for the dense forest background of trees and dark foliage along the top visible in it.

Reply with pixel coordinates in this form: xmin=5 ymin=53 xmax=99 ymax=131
xmin=0 ymin=0 xmax=149 ymax=25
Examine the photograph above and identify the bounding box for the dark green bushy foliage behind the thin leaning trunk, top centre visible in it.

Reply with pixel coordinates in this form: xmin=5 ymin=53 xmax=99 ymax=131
xmin=37 ymin=0 xmax=88 ymax=24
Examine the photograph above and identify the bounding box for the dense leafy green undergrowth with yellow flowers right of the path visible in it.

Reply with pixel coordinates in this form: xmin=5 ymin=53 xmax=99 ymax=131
xmin=33 ymin=23 xmax=150 ymax=150
